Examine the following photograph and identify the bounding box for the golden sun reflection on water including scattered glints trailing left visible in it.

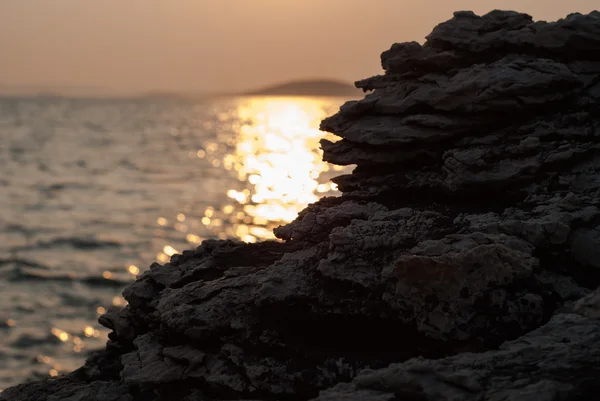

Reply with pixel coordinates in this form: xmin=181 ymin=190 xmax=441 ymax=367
xmin=156 ymin=97 xmax=346 ymax=263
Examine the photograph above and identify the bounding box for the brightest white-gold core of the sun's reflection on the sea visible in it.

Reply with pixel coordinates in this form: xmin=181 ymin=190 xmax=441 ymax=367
xmin=230 ymin=98 xmax=342 ymax=231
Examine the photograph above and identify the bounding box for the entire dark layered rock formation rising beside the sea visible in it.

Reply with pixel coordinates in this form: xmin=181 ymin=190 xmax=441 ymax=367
xmin=0 ymin=11 xmax=600 ymax=401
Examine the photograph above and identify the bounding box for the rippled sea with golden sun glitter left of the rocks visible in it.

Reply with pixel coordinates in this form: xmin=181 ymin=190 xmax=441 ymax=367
xmin=0 ymin=96 xmax=348 ymax=390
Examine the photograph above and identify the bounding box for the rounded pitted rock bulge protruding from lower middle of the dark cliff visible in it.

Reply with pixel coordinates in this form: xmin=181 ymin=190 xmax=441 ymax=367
xmin=383 ymin=244 xmax=544 ymax=341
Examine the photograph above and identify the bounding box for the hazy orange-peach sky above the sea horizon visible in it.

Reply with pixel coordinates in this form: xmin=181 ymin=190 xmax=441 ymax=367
xmin=0 ymin=0 xmax=600 ymax=92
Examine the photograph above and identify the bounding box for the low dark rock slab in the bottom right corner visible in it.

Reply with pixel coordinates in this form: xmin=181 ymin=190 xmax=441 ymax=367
xmin=315 ymin=314 xmax=600 ymax=401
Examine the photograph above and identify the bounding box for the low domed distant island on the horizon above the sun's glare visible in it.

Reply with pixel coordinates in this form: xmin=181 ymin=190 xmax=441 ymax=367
xmin=240 ymin=79 xmax=362 ymax=96
